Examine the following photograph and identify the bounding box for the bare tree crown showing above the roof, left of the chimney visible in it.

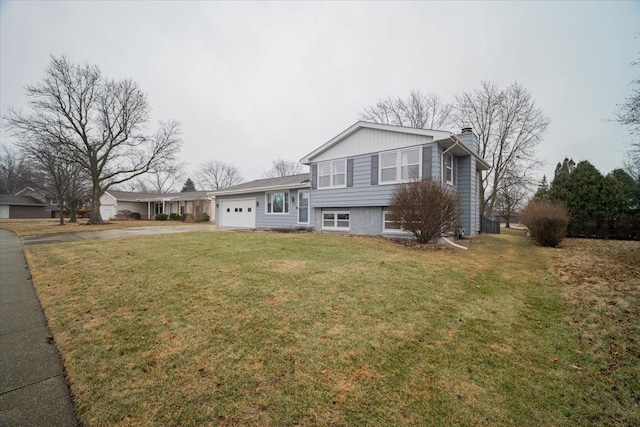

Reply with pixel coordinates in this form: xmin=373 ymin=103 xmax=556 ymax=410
xmin=360 ymin=90 xmax=453 ymax=129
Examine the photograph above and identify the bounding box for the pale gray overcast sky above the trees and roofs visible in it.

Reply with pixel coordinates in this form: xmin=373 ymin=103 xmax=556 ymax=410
xmin=0 ymin=1 xmax=640 ymax=186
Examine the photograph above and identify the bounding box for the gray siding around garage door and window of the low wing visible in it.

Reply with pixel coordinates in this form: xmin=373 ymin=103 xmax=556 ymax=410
xmin=215 ymin=189 xmax=314 ymax=228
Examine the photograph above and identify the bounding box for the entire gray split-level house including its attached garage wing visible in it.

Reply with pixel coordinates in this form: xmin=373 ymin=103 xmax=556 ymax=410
xmin=213 ymin=121 xmax=490 ymax=235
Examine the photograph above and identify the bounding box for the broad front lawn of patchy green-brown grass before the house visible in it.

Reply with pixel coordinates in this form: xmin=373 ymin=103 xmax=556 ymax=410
xmin=27 ymin=233 xmax=640 ymax=426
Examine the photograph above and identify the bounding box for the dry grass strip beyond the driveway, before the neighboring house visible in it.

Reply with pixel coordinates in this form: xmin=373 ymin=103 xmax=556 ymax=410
xmin=0 ymin=218 xmax=188 ymax=237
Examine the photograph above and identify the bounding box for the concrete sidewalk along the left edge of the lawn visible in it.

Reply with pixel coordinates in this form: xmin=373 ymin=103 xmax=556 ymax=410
xmin=0 ymin=229 xmax=78 ymax=427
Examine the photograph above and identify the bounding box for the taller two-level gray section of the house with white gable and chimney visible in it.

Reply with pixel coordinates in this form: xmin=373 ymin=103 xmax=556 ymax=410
xmin=301 ymin=122 xmax=489 ymax=235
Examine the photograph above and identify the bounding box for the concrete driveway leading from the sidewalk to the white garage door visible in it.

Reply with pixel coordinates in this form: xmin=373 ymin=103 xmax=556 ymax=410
xmin=22 ymin=224 xmax=237 ymax=246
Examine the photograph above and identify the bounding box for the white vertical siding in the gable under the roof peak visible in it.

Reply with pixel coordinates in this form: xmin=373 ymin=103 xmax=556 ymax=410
xmin=313 ymin=128 xmax=433 ymax=163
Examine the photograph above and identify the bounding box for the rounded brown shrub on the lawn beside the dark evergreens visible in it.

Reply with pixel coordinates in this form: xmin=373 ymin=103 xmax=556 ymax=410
xmin=520 ymin=199 xmax=569 ymax=247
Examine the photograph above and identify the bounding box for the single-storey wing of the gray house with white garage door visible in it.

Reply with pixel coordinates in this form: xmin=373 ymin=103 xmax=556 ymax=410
xmin=210 ymin=173 xmax=312 ymax=228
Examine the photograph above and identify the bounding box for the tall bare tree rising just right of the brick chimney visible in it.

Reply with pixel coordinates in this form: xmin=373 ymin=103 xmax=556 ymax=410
xmin=454 ymin=82 xmax=550 ymax=216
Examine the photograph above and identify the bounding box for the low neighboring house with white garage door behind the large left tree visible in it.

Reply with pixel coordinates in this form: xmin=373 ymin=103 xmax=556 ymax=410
xmin=100 ymin=190 xmax=215 ymax=221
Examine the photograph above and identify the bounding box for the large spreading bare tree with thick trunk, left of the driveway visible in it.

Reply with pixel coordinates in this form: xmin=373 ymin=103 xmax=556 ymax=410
xmin=4 ymin=57 xmax=182 ymax=224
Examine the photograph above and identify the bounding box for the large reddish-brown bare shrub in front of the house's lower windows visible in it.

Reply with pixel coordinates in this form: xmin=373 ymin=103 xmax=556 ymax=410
xmin=389 ymin=180 xmax=459 ymax=243
